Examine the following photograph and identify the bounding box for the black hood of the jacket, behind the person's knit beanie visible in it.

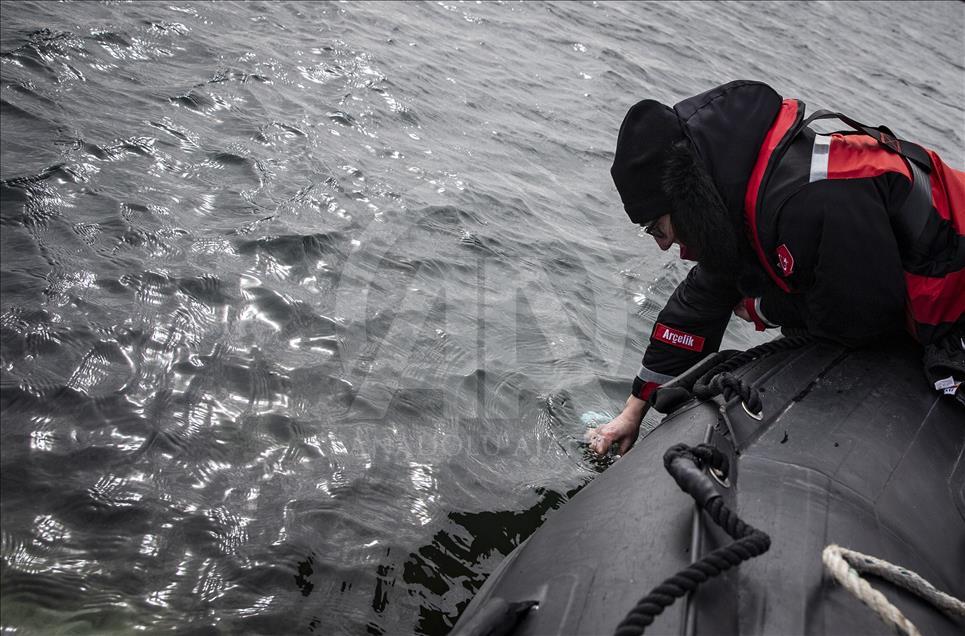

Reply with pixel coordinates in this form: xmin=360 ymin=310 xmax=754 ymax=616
xmin=674 ymin=80 xmax=783 ymax=217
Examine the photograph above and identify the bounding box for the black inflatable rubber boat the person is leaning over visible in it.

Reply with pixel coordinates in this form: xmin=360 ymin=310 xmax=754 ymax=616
xmin=453 ymin=339 xmax=965 ymax=636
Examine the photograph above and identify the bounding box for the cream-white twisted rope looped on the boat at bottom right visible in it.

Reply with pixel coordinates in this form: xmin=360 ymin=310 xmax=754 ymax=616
xmin=821 ymin=543 xmax=965 ymax=636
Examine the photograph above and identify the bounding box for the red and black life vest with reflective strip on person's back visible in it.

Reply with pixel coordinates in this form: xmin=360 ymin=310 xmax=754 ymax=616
xmin=744 ymin=99 xmax=965 ymax=339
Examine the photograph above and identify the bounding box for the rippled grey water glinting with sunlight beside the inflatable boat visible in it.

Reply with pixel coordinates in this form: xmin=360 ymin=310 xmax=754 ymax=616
xmin=0 ymin=0 xmax=965 ymax=634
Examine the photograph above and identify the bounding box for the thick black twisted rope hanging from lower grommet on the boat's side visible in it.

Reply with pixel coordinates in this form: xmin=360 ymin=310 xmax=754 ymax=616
xmin=615 ymin=444 xmax=771 ymax=636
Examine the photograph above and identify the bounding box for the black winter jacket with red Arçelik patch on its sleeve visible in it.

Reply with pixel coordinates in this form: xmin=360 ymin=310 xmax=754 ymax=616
xmin=632 ymin=81 xmax=965 ymax=399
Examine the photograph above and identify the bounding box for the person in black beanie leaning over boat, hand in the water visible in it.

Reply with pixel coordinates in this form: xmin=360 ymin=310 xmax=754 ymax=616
xmin=588 ymin=81 xmax=965 ymax=454
